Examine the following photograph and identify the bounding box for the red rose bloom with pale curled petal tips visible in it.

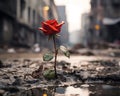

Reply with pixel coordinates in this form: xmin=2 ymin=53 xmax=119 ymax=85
xmin=38 ymin=19 xmax=64 ymax=35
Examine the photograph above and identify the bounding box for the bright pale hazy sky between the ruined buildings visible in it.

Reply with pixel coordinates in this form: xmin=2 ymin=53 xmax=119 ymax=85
xmin=55 ymin=0 xmax=90 ymax=32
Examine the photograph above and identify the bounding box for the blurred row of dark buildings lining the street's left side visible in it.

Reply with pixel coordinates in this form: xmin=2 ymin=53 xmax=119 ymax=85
xmin=0 ymin=0 xmax=58 ymax=47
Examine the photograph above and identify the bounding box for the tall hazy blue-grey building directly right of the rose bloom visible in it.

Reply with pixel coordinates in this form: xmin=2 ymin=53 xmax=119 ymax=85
xmin=57 ymin=5 xmax=69 ymax=45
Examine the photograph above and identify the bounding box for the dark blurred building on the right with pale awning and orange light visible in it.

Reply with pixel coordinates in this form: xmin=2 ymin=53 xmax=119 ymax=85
xmin=90 ymin=0 xmax=120 ymax=42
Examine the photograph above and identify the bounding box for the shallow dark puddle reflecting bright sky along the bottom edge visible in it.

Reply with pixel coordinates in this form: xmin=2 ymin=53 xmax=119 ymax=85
xmin=3 ymin=84 xmax=120 ymax=96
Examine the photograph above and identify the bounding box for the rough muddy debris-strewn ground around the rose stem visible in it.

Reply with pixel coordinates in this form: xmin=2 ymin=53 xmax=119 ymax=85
xmin=0 ymin=50 xmax=120 ymax=96
